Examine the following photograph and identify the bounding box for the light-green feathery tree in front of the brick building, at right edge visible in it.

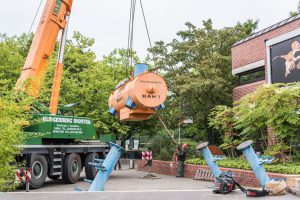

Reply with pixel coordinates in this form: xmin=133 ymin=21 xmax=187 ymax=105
xmin=235 ymin=83 xmax=300 ymax=161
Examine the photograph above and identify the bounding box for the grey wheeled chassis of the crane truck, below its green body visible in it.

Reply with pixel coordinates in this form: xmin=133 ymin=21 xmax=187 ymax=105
xmin=18 ymin=142 xmax=108 ymax=189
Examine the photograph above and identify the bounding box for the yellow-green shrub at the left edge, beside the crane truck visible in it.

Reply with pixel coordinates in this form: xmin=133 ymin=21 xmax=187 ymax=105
xmin=0 ymin=93 xmax=29 ymax=191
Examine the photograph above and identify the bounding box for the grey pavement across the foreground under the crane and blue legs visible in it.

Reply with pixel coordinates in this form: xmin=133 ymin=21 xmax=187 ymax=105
xmin=0 ymin=169 xmax=299 ymax=200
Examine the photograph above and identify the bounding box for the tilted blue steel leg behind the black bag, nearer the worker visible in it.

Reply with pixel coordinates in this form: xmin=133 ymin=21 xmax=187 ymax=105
xmin=196 ymin=142 xmax=222 ymax=177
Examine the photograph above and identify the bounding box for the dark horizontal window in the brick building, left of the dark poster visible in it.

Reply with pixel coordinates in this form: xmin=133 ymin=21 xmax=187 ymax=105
xmin=238 ymin=67 xmax=265 ymax=85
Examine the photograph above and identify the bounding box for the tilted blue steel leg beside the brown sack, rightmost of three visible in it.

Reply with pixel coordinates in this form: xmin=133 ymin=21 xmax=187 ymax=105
xmin=237 ymin=140 xmax=270 ymax=188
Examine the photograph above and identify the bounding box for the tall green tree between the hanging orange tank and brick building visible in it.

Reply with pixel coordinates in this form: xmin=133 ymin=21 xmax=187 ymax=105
xmin=151 ymin=20 xmax=258 ymax=143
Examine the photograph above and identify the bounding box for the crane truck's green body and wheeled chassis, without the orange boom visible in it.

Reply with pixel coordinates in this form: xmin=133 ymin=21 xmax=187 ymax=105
xmin=17 ymin=110 xmax=114 ymax=188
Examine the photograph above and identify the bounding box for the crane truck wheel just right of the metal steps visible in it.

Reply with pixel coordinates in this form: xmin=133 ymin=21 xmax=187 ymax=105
xmin=62 ymin=153 xmax=82 ymax=184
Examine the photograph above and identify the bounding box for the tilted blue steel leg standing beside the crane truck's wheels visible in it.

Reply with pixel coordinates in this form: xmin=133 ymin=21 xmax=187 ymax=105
xmin=88 ymin=143 xmax=125 ymax=192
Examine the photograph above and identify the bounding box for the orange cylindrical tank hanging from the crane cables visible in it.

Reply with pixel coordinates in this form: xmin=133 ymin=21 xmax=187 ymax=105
xmin=109 ymin=64 xmax=168 ymax=121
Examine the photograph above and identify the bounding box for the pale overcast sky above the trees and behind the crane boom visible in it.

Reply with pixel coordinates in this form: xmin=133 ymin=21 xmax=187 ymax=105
xmin=0 ymin=0 xmax=298 ymax=59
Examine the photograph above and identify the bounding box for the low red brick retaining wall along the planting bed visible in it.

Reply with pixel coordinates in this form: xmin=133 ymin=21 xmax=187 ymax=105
xmin=137 ymin=160 xmax=296 ymax=188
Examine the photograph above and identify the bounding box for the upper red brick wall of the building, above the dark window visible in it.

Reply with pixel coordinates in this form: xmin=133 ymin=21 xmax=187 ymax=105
xmin=231 ymin=20 xmax=300 ymax=69
